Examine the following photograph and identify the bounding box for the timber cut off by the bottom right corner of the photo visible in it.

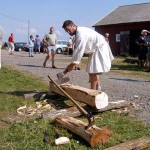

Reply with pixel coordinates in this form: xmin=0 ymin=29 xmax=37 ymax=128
xmin=105 ymin=137 xmax=150 ymax=150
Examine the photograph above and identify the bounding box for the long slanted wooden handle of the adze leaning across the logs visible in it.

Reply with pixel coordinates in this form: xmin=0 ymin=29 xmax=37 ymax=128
xmin=48 ymin=75 xmax=89 ymax=118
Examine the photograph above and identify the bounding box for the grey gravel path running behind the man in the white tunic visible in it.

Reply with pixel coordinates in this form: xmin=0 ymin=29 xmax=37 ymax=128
xmin=2 ymin=50 xmax=150 ymax=123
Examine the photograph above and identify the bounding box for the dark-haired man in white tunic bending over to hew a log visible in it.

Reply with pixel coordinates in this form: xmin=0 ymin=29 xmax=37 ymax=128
xmin=62 ymin=20 xmax=114 ymax=90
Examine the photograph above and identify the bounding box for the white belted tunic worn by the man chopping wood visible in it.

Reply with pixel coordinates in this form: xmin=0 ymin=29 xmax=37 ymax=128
xmin=72 ymin=27 xmax=114 ymax=73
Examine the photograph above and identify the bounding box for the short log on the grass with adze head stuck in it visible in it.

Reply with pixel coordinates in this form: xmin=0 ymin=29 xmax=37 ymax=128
xmin=55 ymin=115 xmax=112 ymax=147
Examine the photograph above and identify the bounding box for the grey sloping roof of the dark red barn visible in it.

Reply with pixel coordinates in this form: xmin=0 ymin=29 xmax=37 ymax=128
xmin=93 ymin=3 xmax=150 ymax=26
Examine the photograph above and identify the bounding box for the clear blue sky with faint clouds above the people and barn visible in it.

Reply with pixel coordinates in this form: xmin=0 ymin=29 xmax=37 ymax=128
xmin=0 ymin=0 xmax=150 ymax=42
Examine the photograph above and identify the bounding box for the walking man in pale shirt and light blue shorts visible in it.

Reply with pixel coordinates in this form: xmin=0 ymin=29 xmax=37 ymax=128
xmin=43 ymin=27 xmax=57 ymax=68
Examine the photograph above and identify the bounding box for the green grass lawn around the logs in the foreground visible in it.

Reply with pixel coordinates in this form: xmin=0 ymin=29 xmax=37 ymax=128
xmin=0 ymin=64 xmax=150 ymax=150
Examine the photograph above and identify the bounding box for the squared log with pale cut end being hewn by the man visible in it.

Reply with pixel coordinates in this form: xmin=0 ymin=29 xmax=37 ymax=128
xmin=50 ymin=82 xmax=108 ymax=109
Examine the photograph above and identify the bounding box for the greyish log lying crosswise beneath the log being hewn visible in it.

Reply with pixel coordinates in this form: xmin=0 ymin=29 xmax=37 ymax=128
xmin=42 ymin=100 xmax=130 ymax=119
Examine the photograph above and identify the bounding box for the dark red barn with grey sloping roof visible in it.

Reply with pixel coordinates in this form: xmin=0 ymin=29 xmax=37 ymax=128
xmin=93 ymin=3 xmax=150 ymax=56
